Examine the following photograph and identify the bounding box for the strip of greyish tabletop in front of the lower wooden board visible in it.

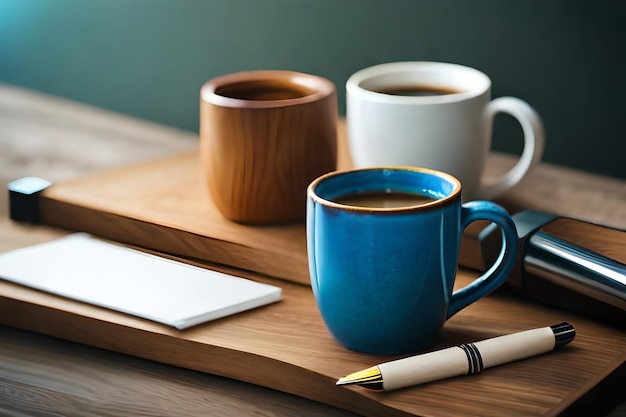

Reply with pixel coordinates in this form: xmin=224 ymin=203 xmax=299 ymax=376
xmin=0 ymin=328 xmax=355 ymax=417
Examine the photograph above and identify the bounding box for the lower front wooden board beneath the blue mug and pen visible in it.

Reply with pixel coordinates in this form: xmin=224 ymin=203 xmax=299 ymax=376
xmin=0 ymin=266 xmax=626 ymax=417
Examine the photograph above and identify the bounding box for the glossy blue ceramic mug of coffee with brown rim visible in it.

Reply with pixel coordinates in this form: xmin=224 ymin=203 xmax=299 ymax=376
xmin=307 ymin=167 xmax=517 ymax=354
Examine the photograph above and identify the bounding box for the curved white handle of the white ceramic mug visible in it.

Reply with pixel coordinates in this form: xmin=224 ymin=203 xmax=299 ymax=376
xmin=479 ymin=97 xmax=545 ymax=200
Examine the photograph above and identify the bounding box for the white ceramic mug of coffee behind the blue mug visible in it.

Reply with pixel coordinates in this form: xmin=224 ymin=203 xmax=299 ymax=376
xmin=346 ymin=62 xmax=544 ymax=201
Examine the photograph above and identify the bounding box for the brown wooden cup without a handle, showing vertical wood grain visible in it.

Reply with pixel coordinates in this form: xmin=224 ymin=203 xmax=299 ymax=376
xmin=200 ymin=71 xmax=337 ymax=224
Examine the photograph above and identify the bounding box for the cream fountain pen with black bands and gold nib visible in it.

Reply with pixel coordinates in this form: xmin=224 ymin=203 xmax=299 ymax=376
xmin=337 ymin=323 xmax=576 ymax=391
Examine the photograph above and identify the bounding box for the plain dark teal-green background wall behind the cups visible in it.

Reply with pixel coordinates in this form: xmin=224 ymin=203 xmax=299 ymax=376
xmin=0 ymin=0 xmax=626 ymax=178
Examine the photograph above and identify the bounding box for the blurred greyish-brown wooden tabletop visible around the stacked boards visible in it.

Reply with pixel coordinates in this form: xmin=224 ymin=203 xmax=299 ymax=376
xmin=0 ymin=84 xmax=626 ymax=416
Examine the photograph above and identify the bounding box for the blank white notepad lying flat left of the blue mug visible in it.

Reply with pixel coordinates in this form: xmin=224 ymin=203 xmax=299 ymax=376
xmin=0 ymin=233 xmax=282 ymax=329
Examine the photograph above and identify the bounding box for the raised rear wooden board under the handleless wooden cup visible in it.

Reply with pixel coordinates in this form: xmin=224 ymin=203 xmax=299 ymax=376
xmin=22 ymin=152 xmax=484 ymax=285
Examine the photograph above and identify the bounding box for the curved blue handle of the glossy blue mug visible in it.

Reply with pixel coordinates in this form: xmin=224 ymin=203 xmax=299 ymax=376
xmin=446 ymin=201 xmax=518 ymax=320
